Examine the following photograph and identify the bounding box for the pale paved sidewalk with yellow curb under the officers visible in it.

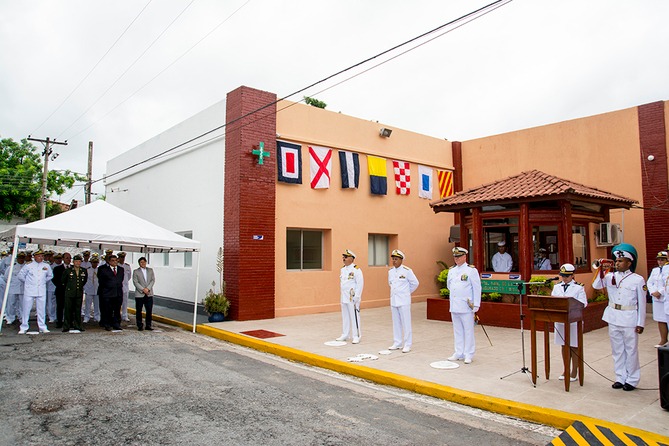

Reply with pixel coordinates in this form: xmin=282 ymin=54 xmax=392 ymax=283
xmin=149 ymin=303 xmax=669 ymax=443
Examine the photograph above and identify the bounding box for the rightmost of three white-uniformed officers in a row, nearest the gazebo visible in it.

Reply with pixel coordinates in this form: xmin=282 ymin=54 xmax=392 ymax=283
xmin=446 ymin=246 xmax=481 ymax=364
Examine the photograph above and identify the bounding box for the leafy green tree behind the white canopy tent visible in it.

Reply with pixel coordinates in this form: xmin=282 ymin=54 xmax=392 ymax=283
xmin=0 ymin=138 xmax=86 ymax=221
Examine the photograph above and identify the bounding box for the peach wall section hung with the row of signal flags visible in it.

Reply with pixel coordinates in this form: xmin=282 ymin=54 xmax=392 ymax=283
xmin=275 ymin=101 xmax=453 ymax=317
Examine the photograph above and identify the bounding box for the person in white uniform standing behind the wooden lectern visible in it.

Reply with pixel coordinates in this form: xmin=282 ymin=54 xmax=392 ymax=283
xmin=551 ymin=263 xmax=588 ymax=382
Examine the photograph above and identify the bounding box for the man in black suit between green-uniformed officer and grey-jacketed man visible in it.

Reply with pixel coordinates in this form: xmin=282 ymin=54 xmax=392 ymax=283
xmin=98 ymin=254 xmax=124 ymax=331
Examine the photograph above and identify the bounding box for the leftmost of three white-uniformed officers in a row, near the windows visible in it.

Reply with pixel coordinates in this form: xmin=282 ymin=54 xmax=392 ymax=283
xmin=337 ymin=249 xmax=365 ymax=344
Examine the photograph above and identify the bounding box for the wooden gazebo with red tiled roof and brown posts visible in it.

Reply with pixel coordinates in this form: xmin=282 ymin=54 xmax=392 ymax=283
xmin=430 ymin=170 xmax=636 ymax=280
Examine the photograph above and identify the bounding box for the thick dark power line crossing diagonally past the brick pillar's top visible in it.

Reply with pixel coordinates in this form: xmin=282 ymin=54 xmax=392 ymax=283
xmin=88 ymin=0 xmax=511 ymax=183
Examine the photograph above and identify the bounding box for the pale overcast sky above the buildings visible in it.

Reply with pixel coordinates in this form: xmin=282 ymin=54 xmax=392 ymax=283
xmin=0 ymin=0 xmax=669 ymax=202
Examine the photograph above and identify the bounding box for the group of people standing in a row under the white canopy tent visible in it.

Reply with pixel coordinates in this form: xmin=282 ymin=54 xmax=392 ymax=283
xmin=0 ymin=250 xmax=155 ymax=334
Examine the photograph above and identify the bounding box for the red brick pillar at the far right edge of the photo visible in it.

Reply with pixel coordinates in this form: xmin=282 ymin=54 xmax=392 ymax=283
xmin=639 ymin=101 xmax=669 ymax=272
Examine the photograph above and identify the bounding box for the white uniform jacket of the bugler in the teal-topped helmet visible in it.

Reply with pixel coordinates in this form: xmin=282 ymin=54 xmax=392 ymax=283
xmin=592 ymin=270 xmax=646 ymax=327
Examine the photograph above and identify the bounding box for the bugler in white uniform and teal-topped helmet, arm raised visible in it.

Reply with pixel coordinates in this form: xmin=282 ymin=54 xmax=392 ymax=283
xmin=592 ymin=243 xmax=646 ymax=391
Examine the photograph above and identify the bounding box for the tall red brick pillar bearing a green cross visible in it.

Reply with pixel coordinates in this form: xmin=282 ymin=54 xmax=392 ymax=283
xmin=223 ymin=87 xmax=277 ymax=321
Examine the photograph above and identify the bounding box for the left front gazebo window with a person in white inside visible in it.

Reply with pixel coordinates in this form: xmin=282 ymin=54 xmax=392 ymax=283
xmin=482 ymin=217 xmax=518 ymax=273
